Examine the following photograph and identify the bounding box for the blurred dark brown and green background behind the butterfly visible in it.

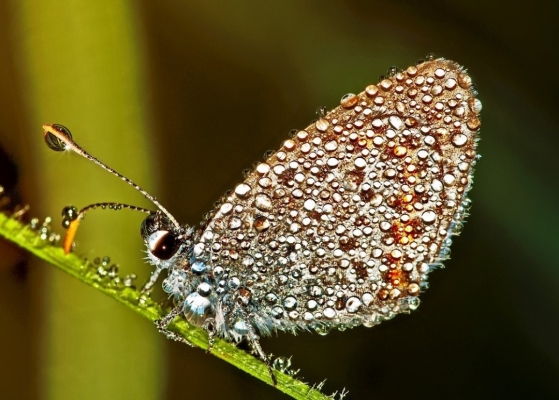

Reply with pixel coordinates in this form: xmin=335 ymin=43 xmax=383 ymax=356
xmin=0 ymin=0 xmax=559 ymax=400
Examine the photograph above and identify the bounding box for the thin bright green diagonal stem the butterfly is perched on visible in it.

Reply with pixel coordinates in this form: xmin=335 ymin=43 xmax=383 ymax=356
xmin=0 ymin=213 xmax=331 ymax=399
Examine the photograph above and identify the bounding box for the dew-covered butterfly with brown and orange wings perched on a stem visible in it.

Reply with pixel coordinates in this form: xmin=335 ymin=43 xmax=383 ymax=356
xmin=43 ymin=56 xmax=481 ymax=383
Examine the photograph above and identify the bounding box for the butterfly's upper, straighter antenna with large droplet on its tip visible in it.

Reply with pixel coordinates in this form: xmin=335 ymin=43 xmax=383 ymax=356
xmin=43 ymin=124 xmax=180 ymax=231
